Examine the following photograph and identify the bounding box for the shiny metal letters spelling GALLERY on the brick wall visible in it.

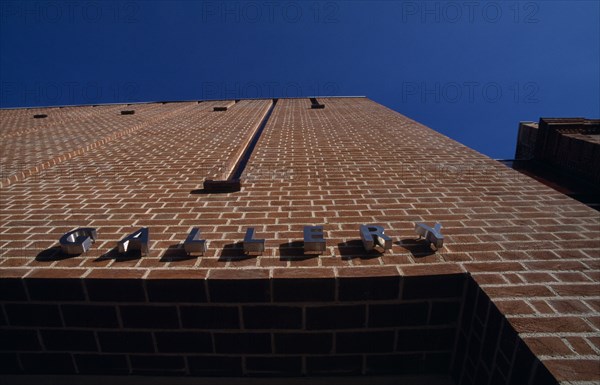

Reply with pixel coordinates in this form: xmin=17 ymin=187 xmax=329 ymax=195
xmin=59 ymin=223 xmax=444 ymax=255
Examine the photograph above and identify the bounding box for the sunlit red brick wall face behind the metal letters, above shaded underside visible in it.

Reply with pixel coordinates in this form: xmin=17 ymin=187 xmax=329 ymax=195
xmin=0 ymin=98 xmax=600 ymax=382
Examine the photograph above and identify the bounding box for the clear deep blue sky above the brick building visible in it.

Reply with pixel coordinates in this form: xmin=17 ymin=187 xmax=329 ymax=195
xmin=0 ymin=0 xmax=600 ymax=158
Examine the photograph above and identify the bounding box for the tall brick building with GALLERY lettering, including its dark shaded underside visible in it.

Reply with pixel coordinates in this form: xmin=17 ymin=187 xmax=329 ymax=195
xmin=0 ymin=98 xmax=600 ymax=385
